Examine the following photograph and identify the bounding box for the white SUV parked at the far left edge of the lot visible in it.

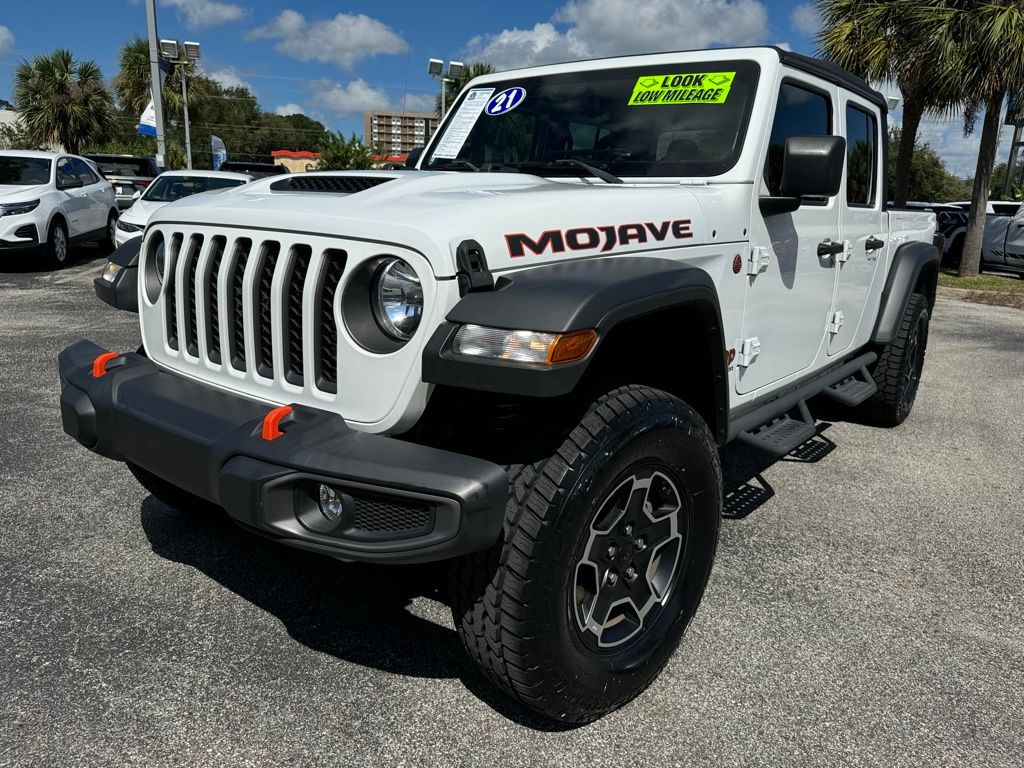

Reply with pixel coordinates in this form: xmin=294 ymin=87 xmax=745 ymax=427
xmin=0 ymin=151 xmax=118 ymax=267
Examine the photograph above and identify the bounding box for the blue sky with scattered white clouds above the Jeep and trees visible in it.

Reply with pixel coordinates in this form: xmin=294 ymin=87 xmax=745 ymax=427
xmin=0 ymin=0 xmax=1007 ymax=175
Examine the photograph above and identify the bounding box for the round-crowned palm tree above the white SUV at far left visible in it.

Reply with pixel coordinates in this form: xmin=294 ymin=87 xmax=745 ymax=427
xmin=14 ymin=49 xmax=113 ymax=154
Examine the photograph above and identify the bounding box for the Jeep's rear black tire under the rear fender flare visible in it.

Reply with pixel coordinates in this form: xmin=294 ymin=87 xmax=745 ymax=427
xmin=858 ymin=293 xmax=929 ymax=427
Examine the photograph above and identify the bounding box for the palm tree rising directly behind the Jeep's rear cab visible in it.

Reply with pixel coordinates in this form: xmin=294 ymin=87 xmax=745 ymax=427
xmin=818 ymin=0 xmax=961 ymax=206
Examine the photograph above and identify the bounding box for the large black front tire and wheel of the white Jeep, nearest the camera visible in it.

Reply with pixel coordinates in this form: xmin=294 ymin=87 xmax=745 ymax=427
xmin=452 ymin=386 xmax=722 ymax=723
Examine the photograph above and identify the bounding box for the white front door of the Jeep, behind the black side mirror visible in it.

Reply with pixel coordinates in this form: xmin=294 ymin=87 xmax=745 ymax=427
xmin=736 ymin=74 xmax=842 ymax=394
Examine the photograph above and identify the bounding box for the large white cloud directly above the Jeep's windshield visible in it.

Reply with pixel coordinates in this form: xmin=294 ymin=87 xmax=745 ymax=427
xmin=465 ymin=0 xmax=768 ymax=69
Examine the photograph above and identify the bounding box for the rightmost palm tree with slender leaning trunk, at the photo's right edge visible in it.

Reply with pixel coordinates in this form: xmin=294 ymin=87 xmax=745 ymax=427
xmin=929 ymin=0 xmax=1024 ymax=276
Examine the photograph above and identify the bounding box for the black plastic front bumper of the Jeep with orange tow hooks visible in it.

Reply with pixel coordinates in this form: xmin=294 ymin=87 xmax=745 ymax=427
xmin=59 ymin=341 xmax=508 ymax=562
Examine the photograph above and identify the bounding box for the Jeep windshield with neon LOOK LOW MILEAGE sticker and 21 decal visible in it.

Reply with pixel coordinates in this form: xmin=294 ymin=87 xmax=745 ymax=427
xmin=422 ymin=60 xmax=759 ymax=176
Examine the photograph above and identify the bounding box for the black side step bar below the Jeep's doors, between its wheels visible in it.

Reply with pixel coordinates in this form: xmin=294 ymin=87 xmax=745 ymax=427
xmin=729 ymin=352 xmax=879 ymax=456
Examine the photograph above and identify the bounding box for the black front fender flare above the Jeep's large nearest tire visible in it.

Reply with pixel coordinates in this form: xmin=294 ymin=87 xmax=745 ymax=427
xmin=423 ymin=256 xmax=728 ymax=438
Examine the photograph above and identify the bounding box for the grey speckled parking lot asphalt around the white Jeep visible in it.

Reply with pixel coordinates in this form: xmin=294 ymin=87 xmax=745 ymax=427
xmin=0 ymin=252 xmax=1024 ymax=768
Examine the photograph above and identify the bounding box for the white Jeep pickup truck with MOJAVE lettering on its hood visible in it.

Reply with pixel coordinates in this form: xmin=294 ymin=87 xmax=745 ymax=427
xmin=59 ymin=47 xmax=938 ymax=722
